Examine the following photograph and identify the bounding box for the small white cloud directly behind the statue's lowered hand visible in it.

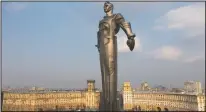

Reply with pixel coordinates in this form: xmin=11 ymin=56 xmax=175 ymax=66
xmin=117 ymin=35 xmax=142 ymax=52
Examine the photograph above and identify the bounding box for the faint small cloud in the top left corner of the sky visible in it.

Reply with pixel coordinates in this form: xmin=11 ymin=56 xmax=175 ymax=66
xmin=3 ymin=2 xmax=28 ymax=12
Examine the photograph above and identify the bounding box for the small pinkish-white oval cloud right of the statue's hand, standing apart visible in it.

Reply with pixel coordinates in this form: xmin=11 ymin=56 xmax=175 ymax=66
xmin=150 ymin=46 xmax=182 ymax=60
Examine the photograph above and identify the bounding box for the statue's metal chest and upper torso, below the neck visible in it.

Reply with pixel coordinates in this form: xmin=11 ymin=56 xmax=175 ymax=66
xmin=99 ymin=14 xmax=120 ymax=36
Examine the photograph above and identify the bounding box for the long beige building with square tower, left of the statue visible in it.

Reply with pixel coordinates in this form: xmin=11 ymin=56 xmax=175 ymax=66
xmin=3 ymin=80 xmax=100 ymax=111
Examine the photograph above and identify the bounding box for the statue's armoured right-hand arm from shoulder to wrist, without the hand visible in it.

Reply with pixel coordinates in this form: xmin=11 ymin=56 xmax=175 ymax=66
xmin=115 ymin=13 xmax=135 ymax=39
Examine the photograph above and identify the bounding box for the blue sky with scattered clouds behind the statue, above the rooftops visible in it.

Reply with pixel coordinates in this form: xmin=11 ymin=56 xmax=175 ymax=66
xmin=2 ymin=2 xmax=205 ymax=88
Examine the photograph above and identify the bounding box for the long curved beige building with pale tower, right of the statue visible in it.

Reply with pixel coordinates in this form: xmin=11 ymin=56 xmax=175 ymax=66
xmin=122 ymin=82 xmax=205 ymax=111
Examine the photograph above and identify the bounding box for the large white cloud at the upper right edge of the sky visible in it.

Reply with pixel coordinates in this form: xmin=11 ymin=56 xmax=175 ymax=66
xmin=154 ymin=3 xmax=205 ymax=37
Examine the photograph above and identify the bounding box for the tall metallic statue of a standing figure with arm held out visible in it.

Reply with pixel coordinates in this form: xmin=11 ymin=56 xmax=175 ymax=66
xmin=96 ymin=1 xmax=135 ymax=111
